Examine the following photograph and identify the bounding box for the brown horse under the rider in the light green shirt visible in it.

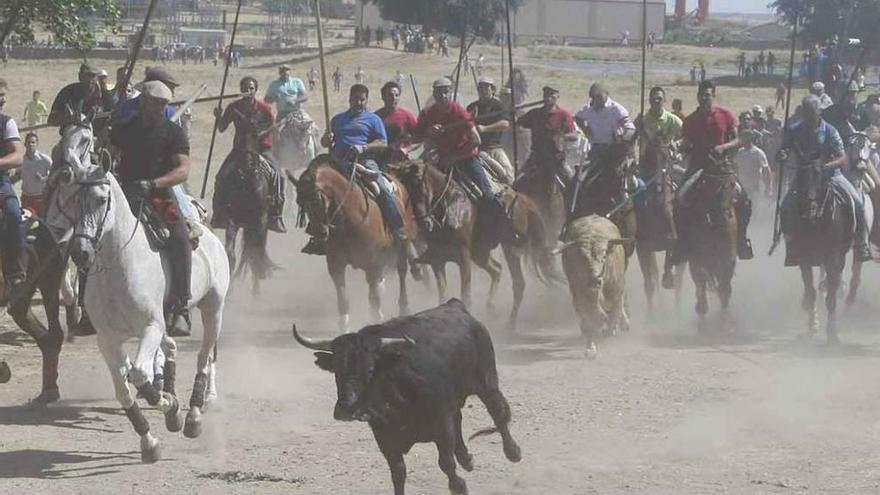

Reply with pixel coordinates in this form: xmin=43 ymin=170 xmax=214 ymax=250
xmin=635 ymin=145 xmax=684 ymax=318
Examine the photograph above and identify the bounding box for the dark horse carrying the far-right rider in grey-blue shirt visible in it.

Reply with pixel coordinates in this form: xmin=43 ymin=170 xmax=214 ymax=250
xmin=783 ymin=153 xmax=855 ymax=344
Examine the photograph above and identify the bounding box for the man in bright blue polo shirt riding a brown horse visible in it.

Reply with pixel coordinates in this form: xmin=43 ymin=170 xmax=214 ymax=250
xmin=302 ymin=84 xmax=406 ymax=254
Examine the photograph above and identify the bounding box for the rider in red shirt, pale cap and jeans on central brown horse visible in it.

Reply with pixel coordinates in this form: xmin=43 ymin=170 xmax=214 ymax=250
xmin=415 ymin=77 xmax=501 ymax=215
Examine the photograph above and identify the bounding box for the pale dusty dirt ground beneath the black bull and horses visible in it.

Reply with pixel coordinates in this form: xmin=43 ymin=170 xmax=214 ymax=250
xmin=0 ymin=44 xmax=880 ymax=495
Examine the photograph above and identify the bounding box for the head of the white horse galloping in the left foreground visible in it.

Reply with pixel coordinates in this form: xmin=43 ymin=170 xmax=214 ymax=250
xmin=44 ymin=164 xmax=114 ymax=270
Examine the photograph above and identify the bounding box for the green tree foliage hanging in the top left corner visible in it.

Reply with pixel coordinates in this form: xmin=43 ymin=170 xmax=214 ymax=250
xmin=0 ymin=0 xmax=119 ymax=50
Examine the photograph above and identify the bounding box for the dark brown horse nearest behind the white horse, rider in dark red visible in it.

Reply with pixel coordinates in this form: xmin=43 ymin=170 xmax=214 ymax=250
xmin=223 ymin=150 xmax=278 ymax=295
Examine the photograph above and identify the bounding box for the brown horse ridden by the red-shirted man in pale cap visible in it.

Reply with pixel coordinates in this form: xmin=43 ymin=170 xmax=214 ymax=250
xmin=391 ymin=161 xmax=561 ymax=328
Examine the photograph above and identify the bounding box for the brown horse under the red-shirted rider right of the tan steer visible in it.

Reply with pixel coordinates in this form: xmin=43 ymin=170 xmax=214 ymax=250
xmin=675 ymin=158 xmax=737 ymax=333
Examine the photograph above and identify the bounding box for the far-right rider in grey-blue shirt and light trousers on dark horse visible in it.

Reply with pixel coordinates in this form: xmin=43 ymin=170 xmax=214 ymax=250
xmin=780 ymin=95 xmax=872 ymax=261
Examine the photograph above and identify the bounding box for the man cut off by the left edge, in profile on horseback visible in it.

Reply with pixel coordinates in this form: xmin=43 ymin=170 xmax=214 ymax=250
xmin=0 ymin=79 xmax=27 ymax=294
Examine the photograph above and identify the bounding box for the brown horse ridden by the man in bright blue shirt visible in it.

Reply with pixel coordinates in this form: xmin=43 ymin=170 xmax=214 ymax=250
xmin=287 ymin=154 xmax=417 ymax=330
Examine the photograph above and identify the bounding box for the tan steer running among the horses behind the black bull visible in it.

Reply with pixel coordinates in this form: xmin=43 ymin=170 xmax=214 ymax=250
xmin=558 ymin=215 xmax=631 ymax=359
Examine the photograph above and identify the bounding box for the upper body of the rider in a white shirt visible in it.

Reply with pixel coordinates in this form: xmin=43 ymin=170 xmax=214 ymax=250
xmin=574 ymin=83 xmax=636 ymax=158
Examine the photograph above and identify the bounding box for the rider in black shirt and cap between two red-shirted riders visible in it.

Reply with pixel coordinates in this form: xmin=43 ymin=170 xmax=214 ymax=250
xmin=467 ymin=77 xmax=514 ymax=185
